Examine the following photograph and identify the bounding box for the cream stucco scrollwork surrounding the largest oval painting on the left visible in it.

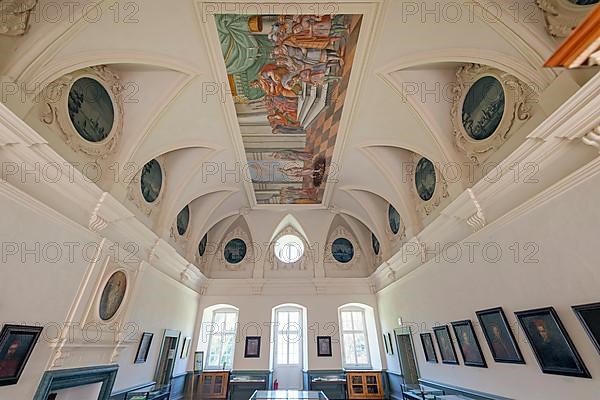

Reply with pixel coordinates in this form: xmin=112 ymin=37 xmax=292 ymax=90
xmin=38 ymin=65 xmax=124 ymax=160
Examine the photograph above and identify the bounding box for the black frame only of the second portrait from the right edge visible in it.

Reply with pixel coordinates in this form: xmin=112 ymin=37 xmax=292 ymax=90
xmin=515 ymin=307 xmax=592 ymax=378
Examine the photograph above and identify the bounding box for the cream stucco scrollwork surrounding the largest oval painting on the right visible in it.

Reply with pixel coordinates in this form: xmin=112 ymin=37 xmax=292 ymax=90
xmin=450 ymin=64 xmax=534 ymax=165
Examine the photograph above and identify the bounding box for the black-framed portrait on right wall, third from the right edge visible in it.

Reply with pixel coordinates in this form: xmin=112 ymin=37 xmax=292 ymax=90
xmin=476 ymin=307 xmax=525 ymax=364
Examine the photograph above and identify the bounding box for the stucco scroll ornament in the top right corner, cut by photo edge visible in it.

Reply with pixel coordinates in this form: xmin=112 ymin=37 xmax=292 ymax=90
xmin=536 ymin=0 xmax=596 ymax=38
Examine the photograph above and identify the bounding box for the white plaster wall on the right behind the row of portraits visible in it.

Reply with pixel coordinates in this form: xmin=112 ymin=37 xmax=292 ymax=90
xmin=377 ymin=173 xmax=600 ymax=400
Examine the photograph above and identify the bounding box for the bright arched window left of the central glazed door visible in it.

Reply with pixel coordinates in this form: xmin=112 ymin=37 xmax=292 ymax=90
xmin=200 ymin=305 xmax=238 ymax=370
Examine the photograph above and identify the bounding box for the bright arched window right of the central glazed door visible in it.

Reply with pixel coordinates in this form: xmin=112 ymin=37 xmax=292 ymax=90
xmin=340 ymin=306 xmax=371 ymax=369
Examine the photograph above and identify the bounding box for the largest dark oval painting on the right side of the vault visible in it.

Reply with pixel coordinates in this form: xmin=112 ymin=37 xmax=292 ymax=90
xmin=462 ymin=76 xmax=504 ymax=140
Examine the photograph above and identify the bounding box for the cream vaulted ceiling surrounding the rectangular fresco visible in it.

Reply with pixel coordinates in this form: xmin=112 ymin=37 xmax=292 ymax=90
xmin=0 ymin=0 xmax=596 ymax=276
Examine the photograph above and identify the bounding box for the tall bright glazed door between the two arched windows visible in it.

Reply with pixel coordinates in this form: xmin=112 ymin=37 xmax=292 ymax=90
xmin=273 ymin=307 xmax=303 ymax=390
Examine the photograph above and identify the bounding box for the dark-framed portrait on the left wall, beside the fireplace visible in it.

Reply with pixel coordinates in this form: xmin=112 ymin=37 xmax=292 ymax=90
xmin=0 ymin=325 xmax=42 ymax=386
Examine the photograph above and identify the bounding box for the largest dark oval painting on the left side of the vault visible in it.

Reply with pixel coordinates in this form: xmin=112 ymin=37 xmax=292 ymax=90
xmin=68 ymin=78 xmax=115 ymax=143
